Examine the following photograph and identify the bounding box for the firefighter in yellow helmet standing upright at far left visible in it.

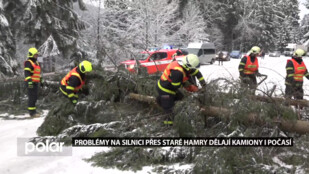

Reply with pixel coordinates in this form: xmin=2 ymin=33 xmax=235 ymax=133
xmin=24 ymin=48 xmax=42 ymax=117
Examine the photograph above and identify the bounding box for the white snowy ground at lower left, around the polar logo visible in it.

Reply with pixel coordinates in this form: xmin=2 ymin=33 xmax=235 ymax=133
xmin=0 ymin=112 xmax=152 ymax=174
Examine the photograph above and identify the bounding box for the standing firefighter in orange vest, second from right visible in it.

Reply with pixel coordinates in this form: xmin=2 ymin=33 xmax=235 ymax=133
xmin=238 ymin=46 xmax=261 ymax=91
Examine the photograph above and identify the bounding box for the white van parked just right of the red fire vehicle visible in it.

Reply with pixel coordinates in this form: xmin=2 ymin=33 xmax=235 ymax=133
xmin=188 ymin=42 xmax=216 ymax=64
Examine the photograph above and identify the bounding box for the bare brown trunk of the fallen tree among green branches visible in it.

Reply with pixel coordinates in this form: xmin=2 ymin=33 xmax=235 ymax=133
xmin=129 ymin=93 xmax=309 ymax=134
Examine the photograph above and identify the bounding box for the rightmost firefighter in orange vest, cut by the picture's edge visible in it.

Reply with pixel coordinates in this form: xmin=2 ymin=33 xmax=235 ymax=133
xmin=285 ymin=49 xmax=309 ymax=99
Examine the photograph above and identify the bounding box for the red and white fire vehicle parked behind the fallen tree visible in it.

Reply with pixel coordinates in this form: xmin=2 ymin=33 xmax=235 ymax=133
xmin=120 ymin=49 xmax=187 ymax=74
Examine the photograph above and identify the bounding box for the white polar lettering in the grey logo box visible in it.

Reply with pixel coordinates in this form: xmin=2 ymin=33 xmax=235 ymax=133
xmin=25 ymin=140 xmax=64 ymax=155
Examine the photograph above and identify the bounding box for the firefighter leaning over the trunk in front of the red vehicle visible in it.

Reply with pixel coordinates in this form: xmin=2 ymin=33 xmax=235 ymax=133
xmin=157 ymin=54 xmax=206 ymax=124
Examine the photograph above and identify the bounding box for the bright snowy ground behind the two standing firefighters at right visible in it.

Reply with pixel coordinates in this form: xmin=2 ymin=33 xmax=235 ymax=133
xmin=200 ymin=55 xmax=309 ymax=99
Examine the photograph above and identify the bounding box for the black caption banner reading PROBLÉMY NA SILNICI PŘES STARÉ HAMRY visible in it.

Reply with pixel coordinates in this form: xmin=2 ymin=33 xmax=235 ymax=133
xmin=72 ymin=137 xmax=293 ymax=147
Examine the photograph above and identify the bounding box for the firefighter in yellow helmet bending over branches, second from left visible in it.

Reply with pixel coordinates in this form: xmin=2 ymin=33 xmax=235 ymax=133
xmin=60 ymin=60 xmax=92 ymax=105
